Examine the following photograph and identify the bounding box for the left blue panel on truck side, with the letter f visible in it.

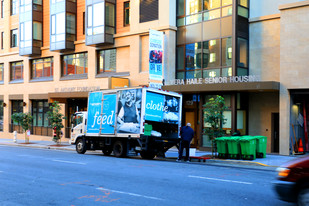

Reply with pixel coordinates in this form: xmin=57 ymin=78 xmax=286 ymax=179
xmin=87 ymin=92 xmax=102 ymax=134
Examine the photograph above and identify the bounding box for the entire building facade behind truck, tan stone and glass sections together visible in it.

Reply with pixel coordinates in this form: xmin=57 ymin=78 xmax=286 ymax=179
xmin=0 ymin=0 xmax=309 ymax=155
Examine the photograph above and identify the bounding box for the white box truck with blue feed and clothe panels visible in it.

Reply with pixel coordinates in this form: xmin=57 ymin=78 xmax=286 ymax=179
xmin=70 ymin=87 xmax=182 ymax=159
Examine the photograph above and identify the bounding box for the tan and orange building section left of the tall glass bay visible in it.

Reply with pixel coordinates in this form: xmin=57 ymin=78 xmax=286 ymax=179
xmin=0 ymin=0 xmax=177 ymax=140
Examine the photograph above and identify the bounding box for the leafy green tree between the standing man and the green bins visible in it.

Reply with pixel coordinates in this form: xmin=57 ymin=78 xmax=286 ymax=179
xmin=204 ymin=95 xmax=227 ymax=157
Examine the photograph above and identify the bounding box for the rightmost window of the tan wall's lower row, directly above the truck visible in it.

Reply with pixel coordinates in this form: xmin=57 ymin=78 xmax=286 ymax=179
xmin=98 ymin=49 xmax=116 ymax=74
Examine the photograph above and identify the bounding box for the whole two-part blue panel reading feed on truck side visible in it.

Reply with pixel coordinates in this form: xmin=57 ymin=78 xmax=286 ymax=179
xmin=87 ymin=92 xmax=116 ymax=134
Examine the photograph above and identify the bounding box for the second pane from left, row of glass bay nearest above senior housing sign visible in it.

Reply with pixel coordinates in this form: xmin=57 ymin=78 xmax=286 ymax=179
xmin=186 ymin=42 xmax=202 ymax=70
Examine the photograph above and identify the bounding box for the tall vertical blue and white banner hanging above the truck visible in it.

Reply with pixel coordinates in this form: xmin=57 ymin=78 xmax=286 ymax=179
xmin=149 ymin=29 xmax=163 ymax=81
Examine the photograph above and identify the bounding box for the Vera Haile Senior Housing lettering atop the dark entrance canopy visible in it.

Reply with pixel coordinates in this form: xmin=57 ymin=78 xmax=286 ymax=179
xmin=170 ymin=75 xmax=261 ymax=85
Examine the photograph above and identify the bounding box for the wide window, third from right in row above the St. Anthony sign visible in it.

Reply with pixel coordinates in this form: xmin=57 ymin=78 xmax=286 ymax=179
xmin=31 ymin=58 xmax=54 ymax=79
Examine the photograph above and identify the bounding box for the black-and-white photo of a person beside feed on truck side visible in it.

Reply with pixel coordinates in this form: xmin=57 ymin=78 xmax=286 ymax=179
xmin=117 ymin=90 xmax=140 ymax=133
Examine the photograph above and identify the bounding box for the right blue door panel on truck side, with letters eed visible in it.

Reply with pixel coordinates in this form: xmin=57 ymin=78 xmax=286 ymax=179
xmin=100 ymin=94 xmax=117 ymax=134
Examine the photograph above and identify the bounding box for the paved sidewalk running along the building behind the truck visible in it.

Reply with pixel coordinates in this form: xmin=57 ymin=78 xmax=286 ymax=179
xmin=0 ymin=139 xmax=301 ymax=169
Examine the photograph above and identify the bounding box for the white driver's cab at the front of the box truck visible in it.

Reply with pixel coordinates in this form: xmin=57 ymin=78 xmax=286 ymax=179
xmin=70 ymin=112 xmax=87 ymax=144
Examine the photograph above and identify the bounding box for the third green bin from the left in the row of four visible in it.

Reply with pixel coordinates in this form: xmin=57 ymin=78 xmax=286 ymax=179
xmin=240 ymin=136 xmax=256 ymax=160
